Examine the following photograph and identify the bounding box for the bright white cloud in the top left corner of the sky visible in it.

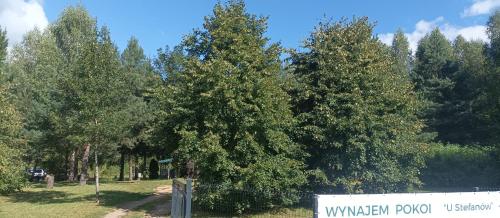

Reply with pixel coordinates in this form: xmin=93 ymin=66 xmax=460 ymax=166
xmin=0 ymin=0 xmax=49 ymax=47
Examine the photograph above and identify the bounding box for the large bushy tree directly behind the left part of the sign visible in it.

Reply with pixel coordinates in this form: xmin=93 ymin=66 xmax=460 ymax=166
xmin=291 ymin=18 xmax=423 ymax=193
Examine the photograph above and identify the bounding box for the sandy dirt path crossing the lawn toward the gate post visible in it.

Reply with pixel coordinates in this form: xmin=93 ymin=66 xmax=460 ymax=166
xmin=104 ymin=185 xmax=172 ymax=218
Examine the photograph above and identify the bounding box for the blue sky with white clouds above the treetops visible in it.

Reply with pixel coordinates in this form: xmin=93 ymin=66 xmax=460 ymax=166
xmin=0 ymin=0 xmax=500 ymax=57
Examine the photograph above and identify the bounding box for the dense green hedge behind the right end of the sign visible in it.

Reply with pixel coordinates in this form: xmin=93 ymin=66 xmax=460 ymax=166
xmin=422 ymin=144 xmax=500 ymax=188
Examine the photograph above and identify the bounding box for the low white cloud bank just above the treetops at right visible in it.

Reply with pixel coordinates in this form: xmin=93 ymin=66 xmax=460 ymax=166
xmin=378 ymin=17 xmax=488 ymax=52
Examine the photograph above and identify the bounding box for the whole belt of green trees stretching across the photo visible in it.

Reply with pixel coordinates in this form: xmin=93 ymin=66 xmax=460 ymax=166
xmin=0 ymin=1 xmax=500 ymax=213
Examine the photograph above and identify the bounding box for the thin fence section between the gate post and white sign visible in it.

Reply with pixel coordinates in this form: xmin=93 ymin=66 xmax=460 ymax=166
xmin=192 ymin=184 xmax=314 ymax=218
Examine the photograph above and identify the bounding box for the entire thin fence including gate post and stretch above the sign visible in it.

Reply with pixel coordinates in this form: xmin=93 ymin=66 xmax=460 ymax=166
xmin=171 ymin=182 xmax=500 ymax=218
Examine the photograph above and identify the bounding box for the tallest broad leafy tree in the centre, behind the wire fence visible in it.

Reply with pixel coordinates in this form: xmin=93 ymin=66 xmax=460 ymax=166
xmin=162 ymin=1 xmax=305 ymax=212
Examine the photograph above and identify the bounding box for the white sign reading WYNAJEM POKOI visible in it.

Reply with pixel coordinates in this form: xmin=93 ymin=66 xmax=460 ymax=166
xmin=316 ymin=192 xmax=500 ymax=218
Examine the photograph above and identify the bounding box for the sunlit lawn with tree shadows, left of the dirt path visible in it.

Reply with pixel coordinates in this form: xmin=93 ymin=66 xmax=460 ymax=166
xmin=0 ymin=180 xmax=171 ymax=217
